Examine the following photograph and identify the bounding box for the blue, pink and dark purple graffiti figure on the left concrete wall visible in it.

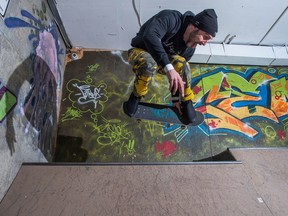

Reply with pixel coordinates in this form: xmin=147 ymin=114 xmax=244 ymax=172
xmin=4 ymin=1 xmax=65 ymax=158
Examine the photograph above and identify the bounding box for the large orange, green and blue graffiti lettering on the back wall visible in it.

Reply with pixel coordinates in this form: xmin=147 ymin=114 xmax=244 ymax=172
xmin=193 ymin=68 xmax=288 ymax=139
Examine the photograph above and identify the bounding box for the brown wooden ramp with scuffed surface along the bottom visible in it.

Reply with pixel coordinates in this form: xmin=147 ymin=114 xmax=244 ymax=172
xmin=0 ymin=148 xmax=288 ymax=216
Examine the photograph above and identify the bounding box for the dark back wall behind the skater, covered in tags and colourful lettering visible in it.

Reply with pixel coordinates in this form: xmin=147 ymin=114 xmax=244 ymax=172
xmin=55 ymin=51 xmax=288 ymax=162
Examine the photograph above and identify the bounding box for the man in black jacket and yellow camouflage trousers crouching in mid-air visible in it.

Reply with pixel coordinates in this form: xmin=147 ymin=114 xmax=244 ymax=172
xmin=123 ymin=9 xmax=218 ymax=122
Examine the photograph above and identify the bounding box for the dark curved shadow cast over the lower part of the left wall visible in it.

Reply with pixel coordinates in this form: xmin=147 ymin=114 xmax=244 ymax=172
xmin=6 ymin=55 xmax=57 ymax=161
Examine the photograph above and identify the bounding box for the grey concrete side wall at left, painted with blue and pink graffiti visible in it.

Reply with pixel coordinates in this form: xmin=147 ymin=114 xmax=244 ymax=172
xmin=0 ymin=0 xmax=66 ymax=199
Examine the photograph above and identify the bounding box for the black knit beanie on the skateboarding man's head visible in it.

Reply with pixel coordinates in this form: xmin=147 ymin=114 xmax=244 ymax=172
xmin=192 ymin=9 xmax=218 ymax=37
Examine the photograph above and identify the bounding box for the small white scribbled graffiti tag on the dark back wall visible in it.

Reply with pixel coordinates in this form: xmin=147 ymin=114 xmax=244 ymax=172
xmin=73 ymin=83 xmax=102 ymax=109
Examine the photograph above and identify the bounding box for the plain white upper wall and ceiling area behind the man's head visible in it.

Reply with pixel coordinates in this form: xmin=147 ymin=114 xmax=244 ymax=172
xmin=55 ymin=0 xmax=288 ymax=65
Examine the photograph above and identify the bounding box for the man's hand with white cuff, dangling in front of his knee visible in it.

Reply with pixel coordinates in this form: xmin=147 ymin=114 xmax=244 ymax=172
xmin=167 ymin=69 xmax=184 ymax=97
